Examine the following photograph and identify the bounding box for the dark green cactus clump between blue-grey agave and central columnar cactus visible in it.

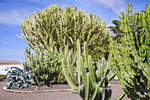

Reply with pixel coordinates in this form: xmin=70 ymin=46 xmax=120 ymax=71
xmin=24 ymin=48 xmax=64 ymax=86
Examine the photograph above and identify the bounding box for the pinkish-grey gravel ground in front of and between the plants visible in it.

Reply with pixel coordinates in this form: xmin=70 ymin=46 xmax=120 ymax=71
xmin=0 ymin=81 xmax=129 ymax=100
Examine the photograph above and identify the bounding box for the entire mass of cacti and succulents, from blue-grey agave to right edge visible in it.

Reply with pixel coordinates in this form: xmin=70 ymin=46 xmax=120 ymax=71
xmin=1 ymin=3 xmax=150 ymax=100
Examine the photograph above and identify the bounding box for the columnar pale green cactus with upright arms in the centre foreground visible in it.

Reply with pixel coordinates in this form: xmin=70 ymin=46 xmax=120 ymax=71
xmin=60 ymin=40 xmax=114 ymax=100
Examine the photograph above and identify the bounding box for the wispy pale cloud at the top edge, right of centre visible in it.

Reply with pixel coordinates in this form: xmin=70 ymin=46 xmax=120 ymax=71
xmin=86 ymin=0 xmax=127 ymax=15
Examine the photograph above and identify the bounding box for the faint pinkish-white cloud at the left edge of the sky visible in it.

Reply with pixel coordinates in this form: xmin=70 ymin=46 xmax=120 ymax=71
xmin=0 ymin=9 xmax=29 ymax=24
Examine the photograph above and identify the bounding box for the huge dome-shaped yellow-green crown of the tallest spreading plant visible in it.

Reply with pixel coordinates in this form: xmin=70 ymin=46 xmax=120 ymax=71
xmin=21 ymin=5 xmax=109 ymax=60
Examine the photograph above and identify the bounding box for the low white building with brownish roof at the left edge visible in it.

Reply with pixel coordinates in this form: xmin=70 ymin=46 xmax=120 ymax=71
xmin=0 ymin=60 xmax=23 ymax=75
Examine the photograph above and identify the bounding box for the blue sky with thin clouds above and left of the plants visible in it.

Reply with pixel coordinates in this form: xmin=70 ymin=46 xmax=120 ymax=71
xmin=0 ymin=0 xmax=150 ymax=61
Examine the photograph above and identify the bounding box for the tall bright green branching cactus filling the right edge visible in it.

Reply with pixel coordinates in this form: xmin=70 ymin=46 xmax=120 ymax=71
xmin=110 ymin=3 xmax=150 ymax=100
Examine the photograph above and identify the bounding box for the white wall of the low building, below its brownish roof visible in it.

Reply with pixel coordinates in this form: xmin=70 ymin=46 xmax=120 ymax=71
xmin=0 ymin=64 xmax=23 ymax=75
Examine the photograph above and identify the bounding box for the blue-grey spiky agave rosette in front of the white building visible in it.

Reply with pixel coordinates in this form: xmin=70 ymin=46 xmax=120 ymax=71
xmin=6 ymin=67 xmax=32 ymax=89
